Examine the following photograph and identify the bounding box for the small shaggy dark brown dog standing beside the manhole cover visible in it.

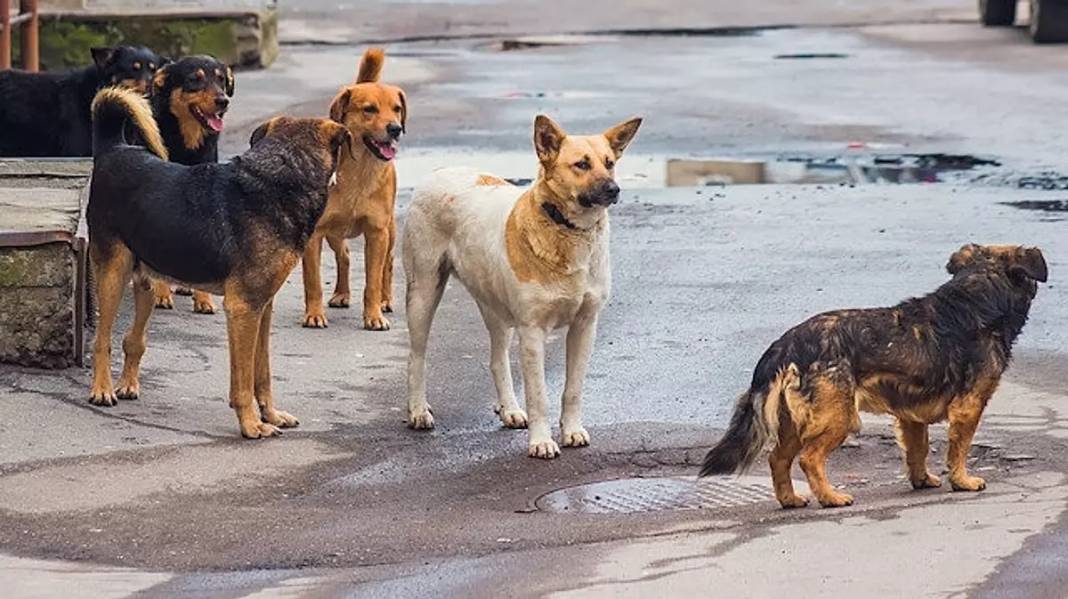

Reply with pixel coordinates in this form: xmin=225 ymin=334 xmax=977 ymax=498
xmin=701 ymin=245 xmax=1047 ymax=507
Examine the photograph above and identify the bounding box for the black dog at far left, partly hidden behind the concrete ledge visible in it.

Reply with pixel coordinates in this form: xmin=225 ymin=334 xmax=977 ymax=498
xmin=0 ymin=46 xmax=167 ymax=157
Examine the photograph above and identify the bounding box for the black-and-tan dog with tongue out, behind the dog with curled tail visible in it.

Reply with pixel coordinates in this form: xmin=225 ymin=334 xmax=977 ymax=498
xmin=152 ymin=56 xmax=234 ymax=314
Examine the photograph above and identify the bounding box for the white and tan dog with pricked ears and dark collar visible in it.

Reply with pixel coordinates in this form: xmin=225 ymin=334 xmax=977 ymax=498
xmin=404 ymin=115 xmax=642 ymax=458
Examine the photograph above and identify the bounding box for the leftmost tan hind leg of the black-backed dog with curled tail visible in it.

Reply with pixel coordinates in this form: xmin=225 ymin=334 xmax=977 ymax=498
xmin=89 ymin=242 xmax=134 ymax=406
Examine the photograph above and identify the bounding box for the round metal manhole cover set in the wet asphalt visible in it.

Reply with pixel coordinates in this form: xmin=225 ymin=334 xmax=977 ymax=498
xmin=535 ymin=476 xmax=807 ymax=514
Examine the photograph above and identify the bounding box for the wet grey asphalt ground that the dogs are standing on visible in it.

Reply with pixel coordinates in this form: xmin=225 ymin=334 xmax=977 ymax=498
xmin=0 ymin=3 xmax=1068 ymax=597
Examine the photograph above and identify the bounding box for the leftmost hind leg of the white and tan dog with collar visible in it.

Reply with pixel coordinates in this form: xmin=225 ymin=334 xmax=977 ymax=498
xmin=405 ymin=257 xmax=450 ymax=430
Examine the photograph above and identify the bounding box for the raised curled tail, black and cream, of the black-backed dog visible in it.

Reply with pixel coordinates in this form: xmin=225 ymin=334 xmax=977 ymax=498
xmin=93 ymin=88 xmax=168 ymax=160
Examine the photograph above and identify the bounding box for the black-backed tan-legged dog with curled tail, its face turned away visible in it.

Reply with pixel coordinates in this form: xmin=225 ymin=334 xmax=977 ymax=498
xmin=87 ymin=88 xmax=351 ymax=438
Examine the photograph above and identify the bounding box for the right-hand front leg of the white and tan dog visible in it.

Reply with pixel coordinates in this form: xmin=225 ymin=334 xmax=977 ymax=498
xmin=560 ymin=306 xmax=599 ymax=447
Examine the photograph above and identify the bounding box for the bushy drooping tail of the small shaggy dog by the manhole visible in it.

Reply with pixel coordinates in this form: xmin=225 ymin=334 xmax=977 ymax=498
xmin=700 ymin=363 xmax=802 ymax=476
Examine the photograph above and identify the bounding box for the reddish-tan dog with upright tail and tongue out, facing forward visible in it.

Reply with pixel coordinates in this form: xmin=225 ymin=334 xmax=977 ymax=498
xmin=303 ymin=49 xmax=408 ymax=331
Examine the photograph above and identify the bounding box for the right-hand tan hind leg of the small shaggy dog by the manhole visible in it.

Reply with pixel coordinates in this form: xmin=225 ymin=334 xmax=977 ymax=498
xmin=799 ymin=377 xmax=857 ymax=507
